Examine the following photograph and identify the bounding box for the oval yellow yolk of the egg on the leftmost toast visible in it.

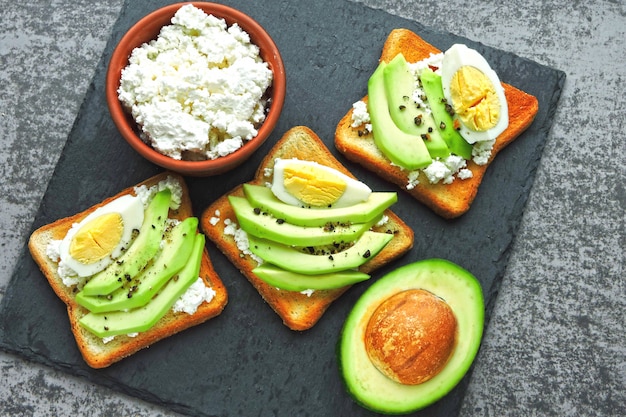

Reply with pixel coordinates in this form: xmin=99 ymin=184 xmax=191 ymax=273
xmin=69 ymin=213 xmax=124 ymax=265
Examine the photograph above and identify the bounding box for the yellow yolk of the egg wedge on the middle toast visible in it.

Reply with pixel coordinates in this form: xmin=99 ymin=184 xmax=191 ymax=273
xmin=283 ymin=165 xmax=347 ymax=207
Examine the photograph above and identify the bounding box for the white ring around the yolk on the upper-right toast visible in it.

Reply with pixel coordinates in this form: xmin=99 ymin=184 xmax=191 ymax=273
xmin=441 ymin=44 xmax=509 ymax=144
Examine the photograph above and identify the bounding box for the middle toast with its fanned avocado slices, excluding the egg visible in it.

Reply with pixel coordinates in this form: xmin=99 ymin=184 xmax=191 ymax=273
xmin=200 ymin=126 xmax=413 ymax=330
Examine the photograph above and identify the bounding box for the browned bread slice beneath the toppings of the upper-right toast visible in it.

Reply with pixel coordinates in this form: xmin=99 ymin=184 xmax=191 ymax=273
xmin=335 ymin=29 xmax=539 ymax=218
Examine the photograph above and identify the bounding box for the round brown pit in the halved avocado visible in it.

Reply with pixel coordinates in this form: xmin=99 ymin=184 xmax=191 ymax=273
xmin=364 ymin=289 xmax=457 ymax=385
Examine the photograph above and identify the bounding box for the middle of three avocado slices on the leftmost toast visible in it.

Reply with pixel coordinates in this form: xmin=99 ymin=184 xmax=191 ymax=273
xmin=76 ymin=217 xmax=198 ymax=313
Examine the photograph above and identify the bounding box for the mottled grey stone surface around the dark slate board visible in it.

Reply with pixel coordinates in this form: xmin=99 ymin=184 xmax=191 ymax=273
xmin=0 ymin=0 xmax=626 ymax=417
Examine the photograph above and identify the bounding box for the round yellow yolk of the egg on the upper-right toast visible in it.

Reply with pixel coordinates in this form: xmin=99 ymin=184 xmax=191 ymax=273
xmin=450 ymin=65 xmax=500 ymax=132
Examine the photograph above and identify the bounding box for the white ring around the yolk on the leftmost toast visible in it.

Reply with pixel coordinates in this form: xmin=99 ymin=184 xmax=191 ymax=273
xmin=59 ymin=195 xmax=144 ymax=277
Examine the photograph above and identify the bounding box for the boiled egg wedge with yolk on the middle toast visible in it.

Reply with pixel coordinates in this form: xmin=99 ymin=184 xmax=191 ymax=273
xmin=272 ymin=158 xmax=372 ymax=208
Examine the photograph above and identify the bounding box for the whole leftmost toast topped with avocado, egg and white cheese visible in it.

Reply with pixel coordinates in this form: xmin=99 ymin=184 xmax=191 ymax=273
xmin=28 ymin=172 xmax=228 ymax=368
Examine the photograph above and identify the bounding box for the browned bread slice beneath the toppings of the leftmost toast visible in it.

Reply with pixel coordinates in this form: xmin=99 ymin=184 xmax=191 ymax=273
xmin=28 ymin=172 xmax=228 ymax=368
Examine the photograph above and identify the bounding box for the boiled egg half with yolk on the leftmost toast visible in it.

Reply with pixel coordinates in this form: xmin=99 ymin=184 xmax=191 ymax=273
xmin=59 ymin=195 xmax=144 ymax=277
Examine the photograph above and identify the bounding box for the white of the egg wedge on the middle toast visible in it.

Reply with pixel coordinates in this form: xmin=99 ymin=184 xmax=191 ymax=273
xmin=271 ymin=158 xmax=372 ymax=207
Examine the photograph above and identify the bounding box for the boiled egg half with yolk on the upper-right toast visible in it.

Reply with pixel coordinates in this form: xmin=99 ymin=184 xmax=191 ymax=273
xmin=441 ymin=44 xmax=509 ymax=144
